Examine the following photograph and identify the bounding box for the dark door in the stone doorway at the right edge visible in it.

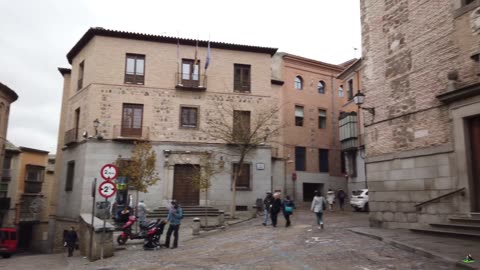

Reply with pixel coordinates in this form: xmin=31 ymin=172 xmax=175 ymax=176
xmin=469 ymin=116 xmax=480 ymax=212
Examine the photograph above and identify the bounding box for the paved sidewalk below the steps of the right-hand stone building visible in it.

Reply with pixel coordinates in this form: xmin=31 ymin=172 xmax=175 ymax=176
xmin=349 ymin=227 xmax=480 ymax=269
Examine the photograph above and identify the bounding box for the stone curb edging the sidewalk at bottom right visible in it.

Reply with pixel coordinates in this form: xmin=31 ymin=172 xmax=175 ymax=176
xmin=348 ymin=228 xmax=479 ymax=270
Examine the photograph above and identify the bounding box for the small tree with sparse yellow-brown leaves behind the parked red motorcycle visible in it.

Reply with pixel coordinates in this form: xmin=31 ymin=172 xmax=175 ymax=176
xmin=115 ymin=142 xmax=160 ymax=229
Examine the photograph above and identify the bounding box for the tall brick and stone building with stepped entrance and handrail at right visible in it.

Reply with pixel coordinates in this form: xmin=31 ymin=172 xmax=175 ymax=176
xmin=361 ymin=0 xmax=480 ymax=228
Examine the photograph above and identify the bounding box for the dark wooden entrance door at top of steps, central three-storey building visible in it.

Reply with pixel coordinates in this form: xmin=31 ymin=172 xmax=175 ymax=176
xmin=173 ymin=164 xmax=200 ymax=205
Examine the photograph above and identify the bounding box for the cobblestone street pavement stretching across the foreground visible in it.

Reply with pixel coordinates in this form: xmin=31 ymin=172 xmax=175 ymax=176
xmin=0 ymin=210 xmax=455 ymax=270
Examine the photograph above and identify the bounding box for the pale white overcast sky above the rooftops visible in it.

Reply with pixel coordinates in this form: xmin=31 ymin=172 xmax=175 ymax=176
xmin=0 ymin=0 xmax=361 ymax=153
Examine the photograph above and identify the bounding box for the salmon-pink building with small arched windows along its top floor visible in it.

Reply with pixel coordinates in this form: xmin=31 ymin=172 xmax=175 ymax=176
xmin=272 ymin=53 xmax=348 ymax=203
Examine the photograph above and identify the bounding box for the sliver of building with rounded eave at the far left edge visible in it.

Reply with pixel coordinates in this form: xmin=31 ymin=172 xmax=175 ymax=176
xmin=0 ymin=83 xmax=18 ymax=227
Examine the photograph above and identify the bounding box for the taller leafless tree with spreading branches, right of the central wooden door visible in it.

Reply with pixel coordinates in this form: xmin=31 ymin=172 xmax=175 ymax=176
xmin=202 ymin=100 xmax=282 ymax=218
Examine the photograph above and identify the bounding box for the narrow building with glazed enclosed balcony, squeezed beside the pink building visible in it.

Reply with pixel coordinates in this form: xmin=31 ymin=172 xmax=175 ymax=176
xmin=337 ymin=59 xmax=368 ymax=191
